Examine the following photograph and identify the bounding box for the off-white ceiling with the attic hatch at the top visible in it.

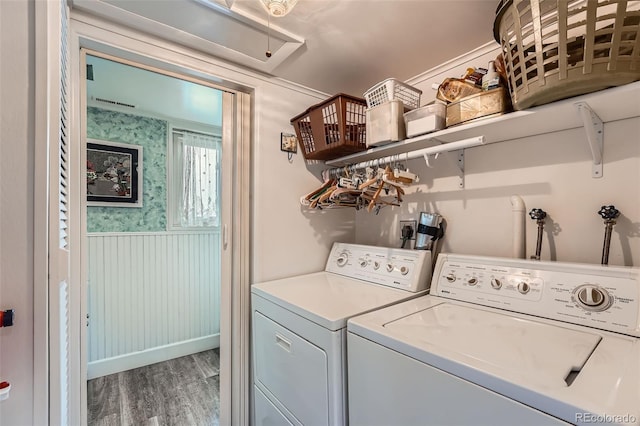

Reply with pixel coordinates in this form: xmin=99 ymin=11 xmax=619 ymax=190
xmin=73 ymin=0 xmax=498 ymax=96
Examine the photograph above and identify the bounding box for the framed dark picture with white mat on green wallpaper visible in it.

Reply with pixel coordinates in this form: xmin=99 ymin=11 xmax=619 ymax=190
xmin=87 ymin=139 xmax=142 ymax=207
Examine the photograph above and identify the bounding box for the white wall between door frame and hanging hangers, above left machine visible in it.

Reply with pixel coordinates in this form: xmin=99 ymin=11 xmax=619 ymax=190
xmin=252 ymin=86 xmax=355 ymax=282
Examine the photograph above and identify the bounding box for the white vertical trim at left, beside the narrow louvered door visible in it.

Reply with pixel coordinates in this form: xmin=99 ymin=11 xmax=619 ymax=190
xmin=33 ymin=0 xmax=69 ymax=424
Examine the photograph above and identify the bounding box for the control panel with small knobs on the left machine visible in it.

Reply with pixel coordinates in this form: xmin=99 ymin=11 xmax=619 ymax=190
xmin=325 ymin=243 xmax=431 ymax=292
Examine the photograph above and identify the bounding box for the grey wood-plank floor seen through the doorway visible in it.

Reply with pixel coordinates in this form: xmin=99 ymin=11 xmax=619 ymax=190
xmin=87 ymin=349 xmax=220 ymax=426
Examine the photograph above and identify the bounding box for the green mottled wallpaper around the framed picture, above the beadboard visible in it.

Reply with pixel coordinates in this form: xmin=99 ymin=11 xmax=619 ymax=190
xmin=87 ymin=107 xmax=167 ymax=232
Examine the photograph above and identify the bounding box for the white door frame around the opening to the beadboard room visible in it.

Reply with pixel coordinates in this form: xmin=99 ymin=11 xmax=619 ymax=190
xmin=62 ymin=12 xmax=252 ymax=425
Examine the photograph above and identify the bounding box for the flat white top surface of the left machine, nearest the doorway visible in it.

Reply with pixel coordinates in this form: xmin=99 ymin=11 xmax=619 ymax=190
xmin=251 ymin=272 xmax=425 ymax=331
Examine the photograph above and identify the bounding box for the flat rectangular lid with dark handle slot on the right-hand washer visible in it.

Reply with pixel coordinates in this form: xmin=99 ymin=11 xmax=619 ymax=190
xmin=384 ymin=303 xmax=601 ymax=387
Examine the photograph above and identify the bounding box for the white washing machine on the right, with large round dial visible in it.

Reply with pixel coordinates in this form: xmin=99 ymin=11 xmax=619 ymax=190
xmin=347 ymin=254 xmax=640 ymax=426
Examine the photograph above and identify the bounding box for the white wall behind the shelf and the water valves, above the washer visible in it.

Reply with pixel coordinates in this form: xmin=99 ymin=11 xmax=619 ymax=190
xmin=356 ymin=45 xmax=640 ymax=266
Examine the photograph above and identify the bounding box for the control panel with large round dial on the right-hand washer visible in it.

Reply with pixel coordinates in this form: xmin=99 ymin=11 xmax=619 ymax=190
xmin=431 ymin=254 xmax=640 ymax=337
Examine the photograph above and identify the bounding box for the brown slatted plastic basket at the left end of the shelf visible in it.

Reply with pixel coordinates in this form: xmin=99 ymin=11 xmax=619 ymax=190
xmin=291 ymin=94 xmax=367 ymax=161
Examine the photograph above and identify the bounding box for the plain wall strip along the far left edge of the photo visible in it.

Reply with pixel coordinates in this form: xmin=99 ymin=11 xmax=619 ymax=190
xmin=0 ymin=1 xmax=34 ymax=425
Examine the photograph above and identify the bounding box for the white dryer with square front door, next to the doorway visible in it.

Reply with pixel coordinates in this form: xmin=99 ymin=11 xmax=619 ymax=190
xmin=251 ymin=243 xmax=431 ymax=426
